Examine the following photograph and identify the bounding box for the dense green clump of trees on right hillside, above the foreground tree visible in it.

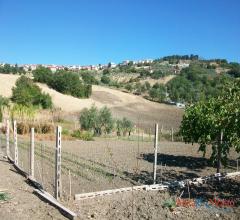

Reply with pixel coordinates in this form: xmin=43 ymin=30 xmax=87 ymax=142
xmin=167 ymin=64 xmax=233 ymax=102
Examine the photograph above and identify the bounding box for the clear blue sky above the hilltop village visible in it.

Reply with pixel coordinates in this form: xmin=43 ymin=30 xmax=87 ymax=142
xmin=0 ymin=0 xmax=240 ymax=65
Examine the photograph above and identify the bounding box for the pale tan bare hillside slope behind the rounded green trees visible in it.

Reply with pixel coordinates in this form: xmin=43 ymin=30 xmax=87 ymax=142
xmin=0 ymin=74 xmax=183 ymax=128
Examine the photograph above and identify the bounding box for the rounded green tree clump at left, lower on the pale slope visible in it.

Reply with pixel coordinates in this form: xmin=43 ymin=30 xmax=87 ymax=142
xmin=11 ymin=76 xmax=52 ymax=109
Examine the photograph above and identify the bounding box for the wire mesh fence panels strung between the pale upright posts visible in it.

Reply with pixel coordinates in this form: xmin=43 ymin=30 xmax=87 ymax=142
xmin=0 ymin=120 xmax=238 ymax=203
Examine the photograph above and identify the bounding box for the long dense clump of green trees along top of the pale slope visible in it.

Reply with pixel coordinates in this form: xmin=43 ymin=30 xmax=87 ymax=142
xmin=33 ymin=66 xmax=92 ymax=98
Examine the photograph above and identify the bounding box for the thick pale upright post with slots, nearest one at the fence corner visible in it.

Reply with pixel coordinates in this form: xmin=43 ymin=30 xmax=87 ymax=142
xmin=55 ymin=126 xmax=62 ymax=200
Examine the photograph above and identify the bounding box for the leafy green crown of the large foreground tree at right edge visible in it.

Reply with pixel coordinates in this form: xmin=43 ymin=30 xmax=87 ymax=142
xmin=180 ymin=80 xmax=240 ymax=173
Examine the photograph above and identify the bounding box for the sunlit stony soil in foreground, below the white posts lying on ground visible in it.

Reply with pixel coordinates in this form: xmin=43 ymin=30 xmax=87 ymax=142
xmin=72 ymin=182 xmax=240 ymax=220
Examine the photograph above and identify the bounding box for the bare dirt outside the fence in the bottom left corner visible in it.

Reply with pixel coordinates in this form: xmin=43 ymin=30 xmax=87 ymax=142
xmin=0 ymin=153 xmax=66 ymax=220
